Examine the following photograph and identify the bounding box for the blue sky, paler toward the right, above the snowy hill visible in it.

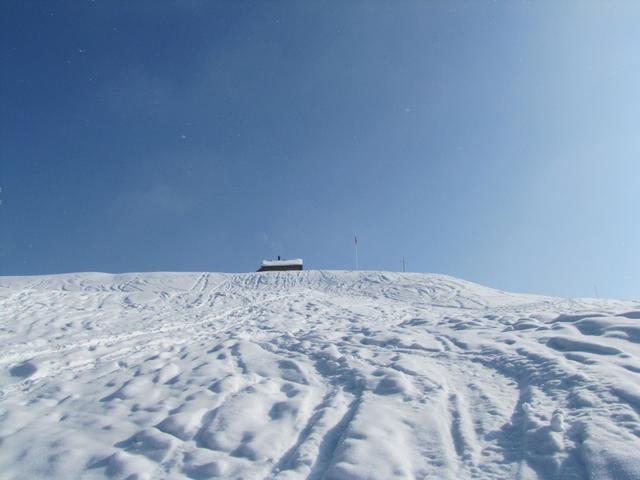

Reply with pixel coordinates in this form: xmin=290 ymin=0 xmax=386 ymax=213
xmin=0 ymin=0 xmax=640 ymax=299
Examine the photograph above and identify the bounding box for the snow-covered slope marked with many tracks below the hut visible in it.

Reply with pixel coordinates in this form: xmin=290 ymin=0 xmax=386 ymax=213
xmin=0 ymin=271 xmax=640 ymax=479
